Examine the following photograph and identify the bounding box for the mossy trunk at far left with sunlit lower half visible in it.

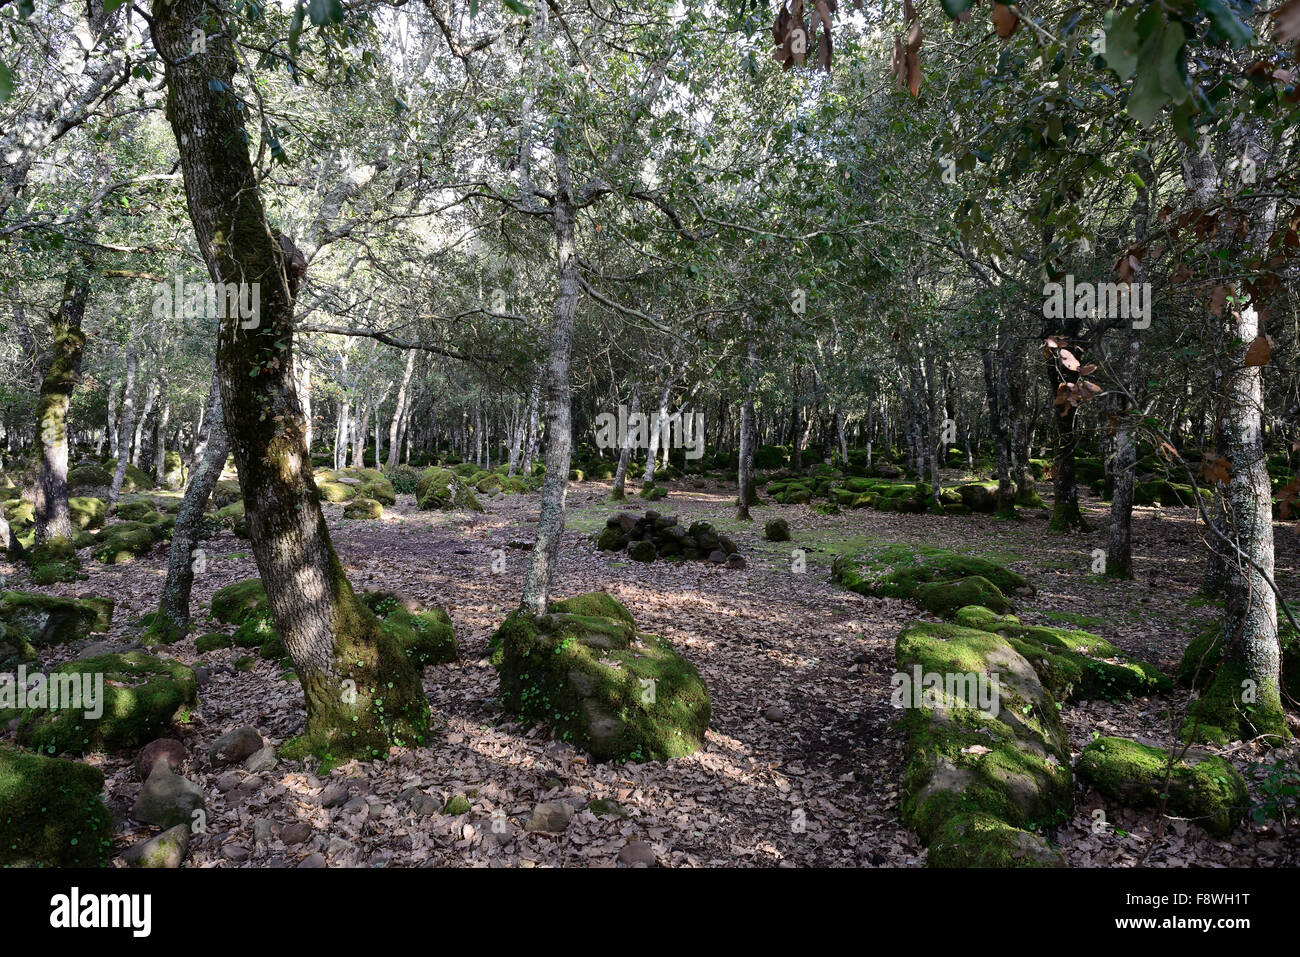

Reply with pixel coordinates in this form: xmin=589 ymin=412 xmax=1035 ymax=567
xmin=35 ymin=259 xmax=90 ymax=545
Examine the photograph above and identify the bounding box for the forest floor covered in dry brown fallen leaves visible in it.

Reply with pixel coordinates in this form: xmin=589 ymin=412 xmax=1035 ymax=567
xmin=0 ymin=481 xmax=1300 ymax=867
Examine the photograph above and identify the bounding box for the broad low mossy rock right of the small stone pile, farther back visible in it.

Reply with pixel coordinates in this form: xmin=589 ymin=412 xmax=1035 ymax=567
xmin=831 ymin=544 xmax=1034 ymax=607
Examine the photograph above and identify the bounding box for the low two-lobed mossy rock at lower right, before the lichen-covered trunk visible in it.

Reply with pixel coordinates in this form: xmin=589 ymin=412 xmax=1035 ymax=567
xmin=1078 ymin=737 xmax=1249 ymax=837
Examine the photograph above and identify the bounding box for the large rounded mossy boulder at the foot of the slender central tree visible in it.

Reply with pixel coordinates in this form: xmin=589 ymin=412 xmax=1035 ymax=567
xmin=491 ymin=594 xmax=711 ymax=761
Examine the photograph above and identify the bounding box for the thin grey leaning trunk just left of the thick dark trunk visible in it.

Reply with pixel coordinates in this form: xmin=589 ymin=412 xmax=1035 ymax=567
xmin=148 ymin=372 xmax=230 ymax=644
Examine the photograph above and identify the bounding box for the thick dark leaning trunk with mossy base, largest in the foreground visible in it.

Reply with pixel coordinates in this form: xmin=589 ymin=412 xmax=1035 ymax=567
xmin=151 ymin=0 xmax=429 ymax=759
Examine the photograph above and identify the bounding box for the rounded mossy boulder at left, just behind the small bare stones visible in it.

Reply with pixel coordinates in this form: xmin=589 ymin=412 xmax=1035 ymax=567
xmin=17 ymin=651 xmax=198 ymax=754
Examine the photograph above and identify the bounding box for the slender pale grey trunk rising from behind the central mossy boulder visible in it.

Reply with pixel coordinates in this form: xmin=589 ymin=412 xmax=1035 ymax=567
xmin=523 ymin=146 xmax=579 ymax=615
